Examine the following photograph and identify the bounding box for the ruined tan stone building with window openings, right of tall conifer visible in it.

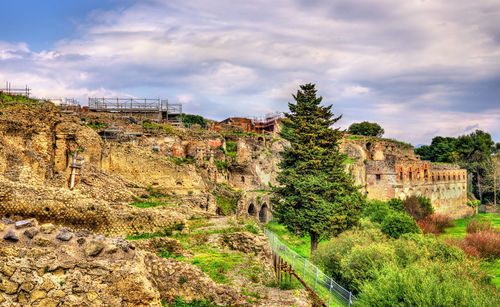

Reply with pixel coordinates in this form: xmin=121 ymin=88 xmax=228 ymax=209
xmin=341 ymin=136 xmax=473 ymax=218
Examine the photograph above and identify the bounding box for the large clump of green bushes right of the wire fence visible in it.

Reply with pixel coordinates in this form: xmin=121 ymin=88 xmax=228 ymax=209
xmin=312 ymin=221 xmax=500 ymax=306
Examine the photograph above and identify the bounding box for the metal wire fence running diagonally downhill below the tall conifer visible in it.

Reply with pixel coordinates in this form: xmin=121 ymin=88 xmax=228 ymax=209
xmin=264 ymin=228 xmax=356 ymax=307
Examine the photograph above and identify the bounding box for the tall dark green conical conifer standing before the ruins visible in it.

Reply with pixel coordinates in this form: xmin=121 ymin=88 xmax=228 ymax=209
xmin=273 ymin=84 xmax=364 ymax=252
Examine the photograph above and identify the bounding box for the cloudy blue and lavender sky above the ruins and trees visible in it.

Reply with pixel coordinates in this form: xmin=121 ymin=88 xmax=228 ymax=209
xmin=0 ymin=0 xmax=500 ymax=145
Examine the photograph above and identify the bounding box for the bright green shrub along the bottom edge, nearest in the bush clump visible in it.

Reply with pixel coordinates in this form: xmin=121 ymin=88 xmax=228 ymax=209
xmin=355 ymin=261 xmax=500 ymax=307
